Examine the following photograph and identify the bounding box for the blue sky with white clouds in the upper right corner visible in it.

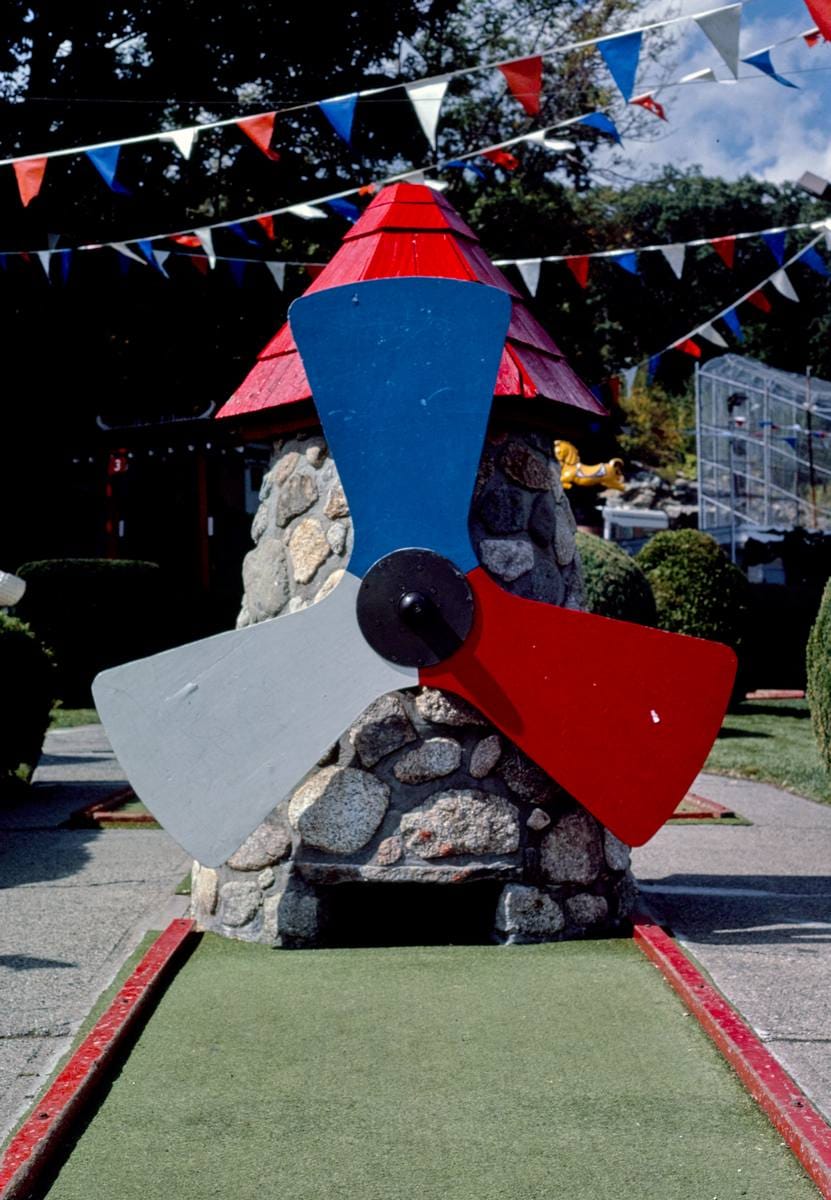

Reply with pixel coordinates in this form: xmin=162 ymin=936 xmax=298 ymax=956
xmin=600 ymin=0 xmax=831 ymax=182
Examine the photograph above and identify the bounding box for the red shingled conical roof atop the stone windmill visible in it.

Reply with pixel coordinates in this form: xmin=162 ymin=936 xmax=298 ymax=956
xmin=216 ymin=184 xmax=606 ymax=429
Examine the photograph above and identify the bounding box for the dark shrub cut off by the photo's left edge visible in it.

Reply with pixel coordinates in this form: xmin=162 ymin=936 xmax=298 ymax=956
xmin=0 ymin=613 xmax=55 ymax=793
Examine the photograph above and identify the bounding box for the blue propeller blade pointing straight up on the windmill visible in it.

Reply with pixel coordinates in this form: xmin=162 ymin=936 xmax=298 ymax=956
xmin=289 ymin=278 xmax=510 ymax=578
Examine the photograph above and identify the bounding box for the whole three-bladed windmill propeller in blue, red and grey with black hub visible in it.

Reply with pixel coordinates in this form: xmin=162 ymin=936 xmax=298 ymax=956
xmin=94 ymin=278 xmax=735 ymax=865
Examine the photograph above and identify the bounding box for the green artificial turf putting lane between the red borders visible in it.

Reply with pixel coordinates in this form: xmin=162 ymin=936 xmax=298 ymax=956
xmin=42 ymin=935 xmax=817 ymax=1200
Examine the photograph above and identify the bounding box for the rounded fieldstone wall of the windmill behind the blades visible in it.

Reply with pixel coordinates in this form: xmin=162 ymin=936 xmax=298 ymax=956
xmin=192 ymin=431 xmax=634 ymax=947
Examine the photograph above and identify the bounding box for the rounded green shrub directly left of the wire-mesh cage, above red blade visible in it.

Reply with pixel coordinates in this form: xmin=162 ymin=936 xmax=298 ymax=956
xmin=635 ymin=529 xmax=748 ymax=650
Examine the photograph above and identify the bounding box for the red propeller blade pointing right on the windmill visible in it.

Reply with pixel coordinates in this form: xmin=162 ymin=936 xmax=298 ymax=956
xmin=419 ymin=568 xmax=736 ymax=846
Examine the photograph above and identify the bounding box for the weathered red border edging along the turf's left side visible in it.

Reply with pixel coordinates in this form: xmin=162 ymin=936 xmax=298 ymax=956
xmin=0 ymin=918 xmax=196 ymax=1200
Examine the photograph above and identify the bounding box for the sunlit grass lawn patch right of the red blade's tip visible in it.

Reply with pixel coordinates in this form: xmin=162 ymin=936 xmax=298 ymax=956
xmin=704 ymin=700 xmax=831 ymax=804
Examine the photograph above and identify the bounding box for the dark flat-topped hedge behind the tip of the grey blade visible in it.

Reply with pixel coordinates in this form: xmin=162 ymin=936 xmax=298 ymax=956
xmin=16 ymin=558 xmax=169 ymax=708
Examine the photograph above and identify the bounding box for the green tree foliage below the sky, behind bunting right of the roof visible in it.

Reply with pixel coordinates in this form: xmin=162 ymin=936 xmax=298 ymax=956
xmin=468 ymin=167 xmax=831 ymax=384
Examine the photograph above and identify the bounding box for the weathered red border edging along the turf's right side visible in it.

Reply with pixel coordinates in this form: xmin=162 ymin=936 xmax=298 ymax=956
xmin=634 ymin=917 xmax=831 ymax=1200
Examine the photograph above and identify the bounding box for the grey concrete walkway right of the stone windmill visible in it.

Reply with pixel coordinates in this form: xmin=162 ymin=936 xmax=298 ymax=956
xmin=633 ymin=775 xmax=831 ymax=1122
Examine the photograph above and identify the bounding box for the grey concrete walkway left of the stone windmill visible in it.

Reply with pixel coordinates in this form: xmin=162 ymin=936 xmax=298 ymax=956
xmin=0 ymin=725 xmax=190 ymax=1141
